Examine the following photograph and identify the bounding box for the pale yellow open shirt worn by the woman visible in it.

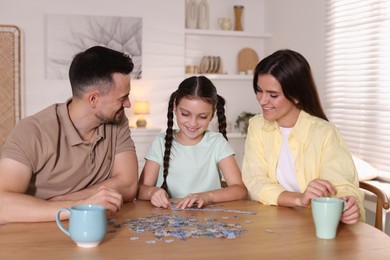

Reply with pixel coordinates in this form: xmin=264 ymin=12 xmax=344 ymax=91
xmin=242 ymin=111 xmax=365 ymax=220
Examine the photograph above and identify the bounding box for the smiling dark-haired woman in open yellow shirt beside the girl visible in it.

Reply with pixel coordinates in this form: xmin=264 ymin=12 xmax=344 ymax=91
xmin=242 ymin=50 xmax=365 ymax=224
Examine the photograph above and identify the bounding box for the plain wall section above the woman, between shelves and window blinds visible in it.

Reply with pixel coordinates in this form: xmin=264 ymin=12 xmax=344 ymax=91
xmin=265 ymin=0 xmax=326 ymax=108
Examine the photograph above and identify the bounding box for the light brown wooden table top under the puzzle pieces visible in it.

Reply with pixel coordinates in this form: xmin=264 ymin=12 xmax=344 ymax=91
xmin=0 ymin=201 xmax=390 ymax=260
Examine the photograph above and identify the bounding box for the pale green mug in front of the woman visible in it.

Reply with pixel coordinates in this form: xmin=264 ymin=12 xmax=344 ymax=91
xmin=311 ymin=197 xmax=345 ymax=239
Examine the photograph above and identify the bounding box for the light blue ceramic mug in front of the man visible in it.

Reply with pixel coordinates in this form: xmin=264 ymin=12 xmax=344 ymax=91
xmin=56 ymin=205 xmax=107 ymax=247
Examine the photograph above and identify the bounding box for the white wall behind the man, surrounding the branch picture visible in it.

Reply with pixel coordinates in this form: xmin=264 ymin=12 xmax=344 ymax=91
xmin=0 ymin=0 xmax=184 ymax=129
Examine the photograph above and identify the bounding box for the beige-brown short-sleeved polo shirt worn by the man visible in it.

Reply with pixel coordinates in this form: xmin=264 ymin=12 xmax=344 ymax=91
xmin=1 ymin=100 xmax=135 ymax=199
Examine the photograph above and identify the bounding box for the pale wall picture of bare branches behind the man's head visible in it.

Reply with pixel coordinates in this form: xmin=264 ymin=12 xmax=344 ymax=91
xmin=46 ymin=14 xmax=142 ymax=79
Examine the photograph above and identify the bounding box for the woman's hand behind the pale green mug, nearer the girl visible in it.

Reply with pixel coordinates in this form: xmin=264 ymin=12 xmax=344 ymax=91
xmin=300 ymin=179 xmax=336 ymax=207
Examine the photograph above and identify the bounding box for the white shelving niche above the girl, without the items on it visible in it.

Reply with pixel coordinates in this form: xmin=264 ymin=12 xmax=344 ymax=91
xmin=183 ymin=0 xmax=272 ymax=84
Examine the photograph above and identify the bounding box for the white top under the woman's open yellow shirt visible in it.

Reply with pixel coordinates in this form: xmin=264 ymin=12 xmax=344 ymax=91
xmin=276 ymin=126 xmax=301 ymax=192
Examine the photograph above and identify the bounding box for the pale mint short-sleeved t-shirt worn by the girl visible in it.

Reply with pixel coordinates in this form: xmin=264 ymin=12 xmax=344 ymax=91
xmin=145 ymin=131 xmax=234 ymax=198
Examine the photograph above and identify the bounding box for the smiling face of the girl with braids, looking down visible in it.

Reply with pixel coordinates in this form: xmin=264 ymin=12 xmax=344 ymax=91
xmin=174 ymin=98 xmax=213 ymax=145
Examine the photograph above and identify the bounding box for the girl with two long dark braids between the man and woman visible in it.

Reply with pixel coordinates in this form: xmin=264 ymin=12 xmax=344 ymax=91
xmin=138 ymin=76 xmax=247 ymax=209
